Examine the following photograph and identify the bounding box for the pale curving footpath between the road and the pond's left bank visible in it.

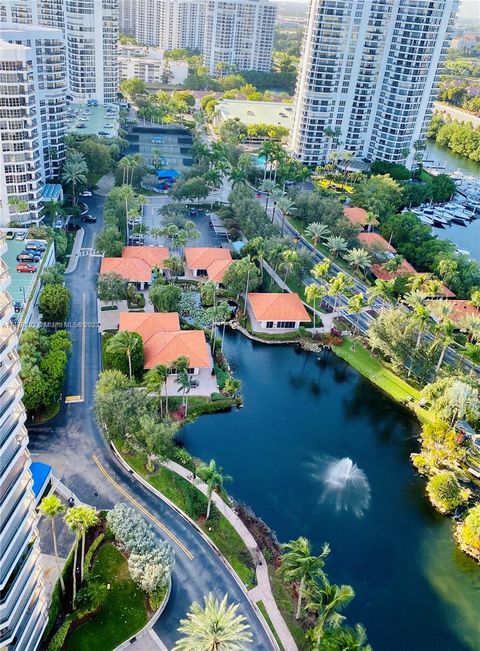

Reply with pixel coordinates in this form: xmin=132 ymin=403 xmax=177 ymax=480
xmin=163 ymin=461 xmax=297 ymax=651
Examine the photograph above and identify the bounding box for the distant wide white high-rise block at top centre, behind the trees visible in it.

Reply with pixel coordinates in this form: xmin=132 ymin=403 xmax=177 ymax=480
xmin=119 ymin=0 xmax=277 ymax=74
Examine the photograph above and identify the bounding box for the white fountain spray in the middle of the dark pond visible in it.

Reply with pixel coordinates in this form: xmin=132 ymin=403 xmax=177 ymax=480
xmin=308 ymin=457 xmax=370 ymax=518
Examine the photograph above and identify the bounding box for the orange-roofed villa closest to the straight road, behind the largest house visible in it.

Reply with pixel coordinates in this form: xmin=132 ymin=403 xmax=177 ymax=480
xmin=100 ymin=246 xmax=170 ymax=289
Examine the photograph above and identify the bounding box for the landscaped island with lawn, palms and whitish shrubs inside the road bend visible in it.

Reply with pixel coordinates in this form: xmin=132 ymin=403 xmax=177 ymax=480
xmin=43 ymin=504 xmax=173 ymax=651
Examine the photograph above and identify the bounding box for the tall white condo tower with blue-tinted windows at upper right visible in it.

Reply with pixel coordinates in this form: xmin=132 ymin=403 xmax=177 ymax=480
xmin=291 ymin=0 xmax=458 ymax=165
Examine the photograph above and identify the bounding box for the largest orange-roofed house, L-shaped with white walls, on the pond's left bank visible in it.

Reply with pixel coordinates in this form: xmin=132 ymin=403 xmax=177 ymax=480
xmin=119 ymin=312 xmax=218 ymax=396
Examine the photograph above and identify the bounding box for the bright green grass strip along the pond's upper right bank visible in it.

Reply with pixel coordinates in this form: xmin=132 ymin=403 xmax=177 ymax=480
xmin=333 ymin=338 xmax=432 ymax=422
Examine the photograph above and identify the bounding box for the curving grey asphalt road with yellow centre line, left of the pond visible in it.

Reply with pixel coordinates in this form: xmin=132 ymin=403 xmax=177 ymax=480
xmin=29 ymin=196 xmax=273 ymax=650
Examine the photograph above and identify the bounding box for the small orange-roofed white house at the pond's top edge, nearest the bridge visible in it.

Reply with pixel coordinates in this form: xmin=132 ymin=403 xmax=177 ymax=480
xmin=247 ymin=292 xmax=311 ymax=334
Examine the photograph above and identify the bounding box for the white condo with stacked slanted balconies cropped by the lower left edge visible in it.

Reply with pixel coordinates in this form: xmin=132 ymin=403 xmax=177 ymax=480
xmin=0 ymin=233 xmax=47 ymax=651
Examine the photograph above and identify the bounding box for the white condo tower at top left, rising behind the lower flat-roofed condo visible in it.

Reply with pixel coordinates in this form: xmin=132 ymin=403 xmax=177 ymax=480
xmin=0 ymin=0 xmax=118 ymax=104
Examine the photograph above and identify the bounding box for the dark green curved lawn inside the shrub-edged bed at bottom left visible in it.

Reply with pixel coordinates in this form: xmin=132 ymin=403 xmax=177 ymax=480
xmin=66 ymin=544 xmax=148 ymax=651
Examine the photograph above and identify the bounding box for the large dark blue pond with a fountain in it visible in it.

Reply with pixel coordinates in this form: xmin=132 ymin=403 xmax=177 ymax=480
xmin=182 ymin=333 xmax=480 ymax=651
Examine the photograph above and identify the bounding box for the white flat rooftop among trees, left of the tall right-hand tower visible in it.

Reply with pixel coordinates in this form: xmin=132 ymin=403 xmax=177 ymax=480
xmin=216 ymin=99 xmax=293 ymax=129
